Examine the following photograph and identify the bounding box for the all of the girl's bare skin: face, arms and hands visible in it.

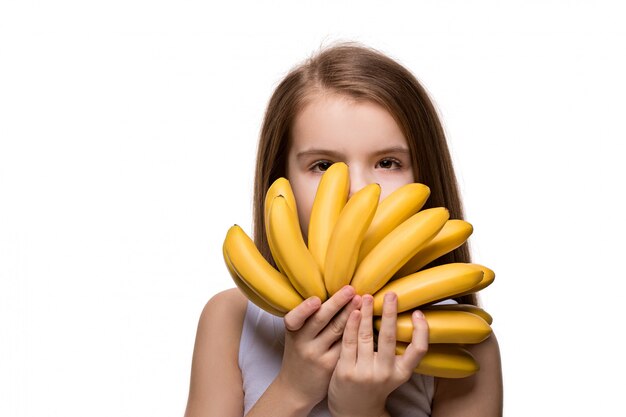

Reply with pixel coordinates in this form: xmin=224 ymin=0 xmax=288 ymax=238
xmin=185 ymin=94 xmax=502 ymax=417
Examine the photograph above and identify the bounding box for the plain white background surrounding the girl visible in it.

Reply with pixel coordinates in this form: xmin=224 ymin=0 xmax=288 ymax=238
xmin=0 ymin=0 xmax=626 ymax=417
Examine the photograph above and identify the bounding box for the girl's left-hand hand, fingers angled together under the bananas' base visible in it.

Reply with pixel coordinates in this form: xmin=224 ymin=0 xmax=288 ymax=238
xmin=276 ymin=286 xmax=361 ymax=408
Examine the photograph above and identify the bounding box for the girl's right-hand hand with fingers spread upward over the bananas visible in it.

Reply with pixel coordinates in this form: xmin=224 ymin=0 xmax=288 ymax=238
xmin=328 ymin=292 xmax=428 ymax=417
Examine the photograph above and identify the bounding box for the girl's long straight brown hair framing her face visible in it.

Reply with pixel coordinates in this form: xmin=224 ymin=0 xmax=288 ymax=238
xmin=253 ymin=43 xmax=477 ymax=304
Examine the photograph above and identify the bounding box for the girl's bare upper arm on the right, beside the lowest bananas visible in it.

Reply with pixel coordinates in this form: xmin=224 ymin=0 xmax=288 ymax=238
xmin=432 ymin=334 xmax=502 ymax=417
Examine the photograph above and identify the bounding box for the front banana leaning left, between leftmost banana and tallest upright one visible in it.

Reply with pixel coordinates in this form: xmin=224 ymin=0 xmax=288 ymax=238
xmin=268 ymin=195 xmax=328 ymax=301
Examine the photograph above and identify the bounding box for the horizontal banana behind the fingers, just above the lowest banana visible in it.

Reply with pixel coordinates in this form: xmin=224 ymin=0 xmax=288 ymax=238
xmin=374 ymin=310 xmax=491 ymax=344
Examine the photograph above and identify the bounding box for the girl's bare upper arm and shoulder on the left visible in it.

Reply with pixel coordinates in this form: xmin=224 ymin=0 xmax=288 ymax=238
xmin=185 ymin=289 xmax=247 ymax=417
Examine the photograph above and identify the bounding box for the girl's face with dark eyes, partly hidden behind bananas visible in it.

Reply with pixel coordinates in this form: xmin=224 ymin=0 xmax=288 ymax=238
xmin=287 ymin=94 xmax=415 ymax=236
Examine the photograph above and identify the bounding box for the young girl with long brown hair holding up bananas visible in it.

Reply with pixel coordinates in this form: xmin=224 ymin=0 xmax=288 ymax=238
xmin=185 ymin=44 xmax=502 ymax=417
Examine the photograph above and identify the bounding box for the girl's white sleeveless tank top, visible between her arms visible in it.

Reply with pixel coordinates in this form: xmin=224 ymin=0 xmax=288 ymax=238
xmin=239 ymin=301 xmax=434 ymax=417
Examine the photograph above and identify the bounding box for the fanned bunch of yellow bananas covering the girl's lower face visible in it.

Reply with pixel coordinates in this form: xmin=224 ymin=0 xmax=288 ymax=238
xmin=223 ymin=163 xmax=495 ymax=378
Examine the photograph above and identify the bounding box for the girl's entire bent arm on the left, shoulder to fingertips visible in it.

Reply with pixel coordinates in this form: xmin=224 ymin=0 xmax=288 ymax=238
xmin=185 ymin=287 xmax=360 ymax=417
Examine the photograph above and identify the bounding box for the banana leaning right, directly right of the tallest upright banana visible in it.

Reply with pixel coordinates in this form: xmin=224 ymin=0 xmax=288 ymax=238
xmin=324 ymin=184 xmax=380 ymax=295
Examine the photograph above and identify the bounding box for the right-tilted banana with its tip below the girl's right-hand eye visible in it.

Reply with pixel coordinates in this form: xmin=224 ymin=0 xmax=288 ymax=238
xmin=357 ymin=183 xmax=430 ymax=264
